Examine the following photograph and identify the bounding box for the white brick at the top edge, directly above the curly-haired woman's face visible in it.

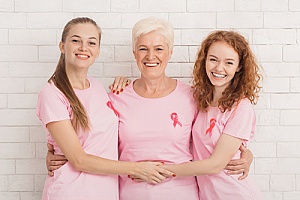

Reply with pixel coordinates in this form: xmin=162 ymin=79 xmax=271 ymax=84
xmin=187 ymin=0 xmax=234 ymax=12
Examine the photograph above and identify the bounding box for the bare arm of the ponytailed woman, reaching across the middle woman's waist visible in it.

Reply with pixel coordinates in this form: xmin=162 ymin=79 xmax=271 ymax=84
xmin=47 ymin=120 xmax=173 ymax=183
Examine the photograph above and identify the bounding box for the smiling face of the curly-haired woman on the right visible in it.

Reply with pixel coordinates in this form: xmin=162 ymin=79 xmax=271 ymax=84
xmin=205 ymin=41 xmax=240 ymax=92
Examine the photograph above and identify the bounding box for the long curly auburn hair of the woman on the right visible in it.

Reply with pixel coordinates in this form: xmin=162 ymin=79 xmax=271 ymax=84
xmin=193 ymin=31 xmax=262 ymax=112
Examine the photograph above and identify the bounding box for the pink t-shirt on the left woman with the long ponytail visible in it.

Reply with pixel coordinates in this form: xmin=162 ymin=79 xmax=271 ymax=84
xmin=37 ymin=78 xmax=119 ymax=200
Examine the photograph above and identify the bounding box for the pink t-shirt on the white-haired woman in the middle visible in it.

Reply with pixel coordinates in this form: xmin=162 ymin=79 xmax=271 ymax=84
xmin=109 ymin=81 xmax=199 ymax=200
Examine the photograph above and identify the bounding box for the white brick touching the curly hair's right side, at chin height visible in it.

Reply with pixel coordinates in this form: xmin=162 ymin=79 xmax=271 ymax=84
xmin=262 ymin=78 xmax=290 ymax=93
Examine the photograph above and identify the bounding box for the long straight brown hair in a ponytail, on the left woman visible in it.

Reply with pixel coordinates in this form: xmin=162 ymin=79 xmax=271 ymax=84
xmin=48 ymin=17 xmax=101 ymax=131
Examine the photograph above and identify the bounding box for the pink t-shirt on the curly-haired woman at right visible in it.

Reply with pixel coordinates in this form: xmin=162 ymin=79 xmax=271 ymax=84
xmin=193 ymin=99 xmax=262 ymax=200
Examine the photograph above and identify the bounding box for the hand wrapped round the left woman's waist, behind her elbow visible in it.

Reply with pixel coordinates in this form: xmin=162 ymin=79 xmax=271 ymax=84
xmin=46 ymin=143 xmax=68 ymax=176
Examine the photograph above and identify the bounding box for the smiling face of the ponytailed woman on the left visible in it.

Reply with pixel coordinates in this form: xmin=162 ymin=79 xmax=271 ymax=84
xmin=59 ymin=23 xmax=100 ymax=70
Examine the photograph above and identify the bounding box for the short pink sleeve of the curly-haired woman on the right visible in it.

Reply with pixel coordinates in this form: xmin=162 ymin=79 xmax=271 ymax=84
xmin=223 ymin=99 xmax=256 ymax=141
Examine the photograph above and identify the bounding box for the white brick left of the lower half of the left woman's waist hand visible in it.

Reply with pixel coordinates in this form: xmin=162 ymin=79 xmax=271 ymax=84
xmin=16 ymin=159 xmax=47 ymax=175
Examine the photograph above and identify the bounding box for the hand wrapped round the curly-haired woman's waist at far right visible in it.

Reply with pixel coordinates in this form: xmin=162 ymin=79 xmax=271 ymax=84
xmin=225 ymin=145 xmax=253 ymax=180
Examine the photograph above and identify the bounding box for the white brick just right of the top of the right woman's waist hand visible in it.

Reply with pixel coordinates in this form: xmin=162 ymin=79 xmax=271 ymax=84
xmin=249 ymin=142 xmax=276 ymax=158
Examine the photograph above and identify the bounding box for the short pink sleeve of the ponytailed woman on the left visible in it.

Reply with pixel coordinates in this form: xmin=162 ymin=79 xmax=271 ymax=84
xmin=36 ymin=84 xmax=71 ymax=125
